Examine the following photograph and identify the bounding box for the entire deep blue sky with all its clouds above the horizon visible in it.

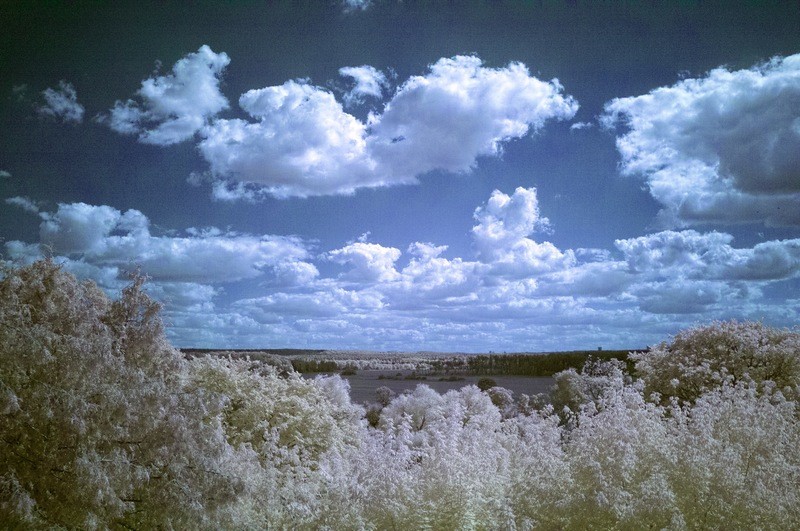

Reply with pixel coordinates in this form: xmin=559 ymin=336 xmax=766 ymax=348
xmin=0 ymin=0 xmax=800 ymax=352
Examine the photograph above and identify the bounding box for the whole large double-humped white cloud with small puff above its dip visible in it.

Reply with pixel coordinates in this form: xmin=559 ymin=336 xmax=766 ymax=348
xmin=199 ymin=56 xmax=578 ymax=197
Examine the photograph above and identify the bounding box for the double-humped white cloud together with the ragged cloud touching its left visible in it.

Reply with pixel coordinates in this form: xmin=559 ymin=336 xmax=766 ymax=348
xmin=109 ymin=46 xmax=578 ymax=197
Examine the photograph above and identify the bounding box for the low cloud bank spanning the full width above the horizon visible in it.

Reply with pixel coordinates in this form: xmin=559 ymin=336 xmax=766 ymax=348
xmin=6 ymin=188 xmax=800 ymax=351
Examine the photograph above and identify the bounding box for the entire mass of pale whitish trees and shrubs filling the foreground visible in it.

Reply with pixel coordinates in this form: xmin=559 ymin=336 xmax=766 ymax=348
xmin=0 ymin=260 xmax=800 ymax=530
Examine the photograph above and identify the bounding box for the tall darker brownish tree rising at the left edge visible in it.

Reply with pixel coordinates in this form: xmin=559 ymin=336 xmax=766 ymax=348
xmin=0 ymin=261 xmax=238 ymax=528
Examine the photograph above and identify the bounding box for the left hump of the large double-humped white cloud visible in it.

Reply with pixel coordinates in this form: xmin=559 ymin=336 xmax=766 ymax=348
xmin=199 ymin=80 xmax=376 ymax=197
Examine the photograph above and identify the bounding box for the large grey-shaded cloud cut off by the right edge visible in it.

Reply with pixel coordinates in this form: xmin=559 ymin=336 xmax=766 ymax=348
xmin=603 ymin=54 xmax=800 ymax=226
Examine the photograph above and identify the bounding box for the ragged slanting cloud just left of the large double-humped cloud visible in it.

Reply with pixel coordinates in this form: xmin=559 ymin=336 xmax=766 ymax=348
xmin=101 ymin=45 xmax=230 ymax=146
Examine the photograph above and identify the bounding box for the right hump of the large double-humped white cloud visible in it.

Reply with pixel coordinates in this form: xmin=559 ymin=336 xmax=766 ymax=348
xmin=369 ymin=56 xmax=578 ymax=181
